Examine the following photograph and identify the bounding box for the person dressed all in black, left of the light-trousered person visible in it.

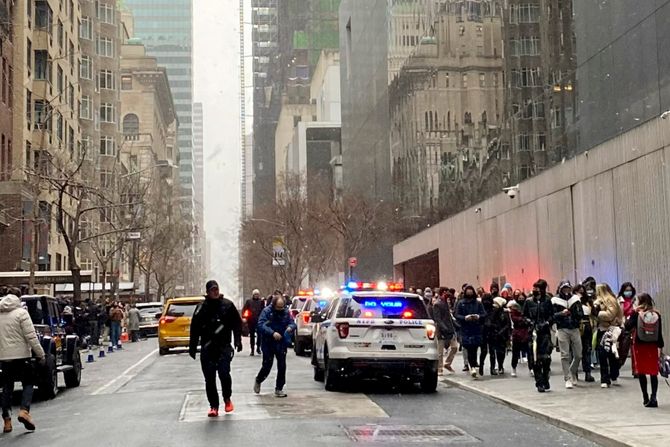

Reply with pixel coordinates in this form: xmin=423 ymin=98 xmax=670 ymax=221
xmin=523 ymin=279 xmax=554 ymax=393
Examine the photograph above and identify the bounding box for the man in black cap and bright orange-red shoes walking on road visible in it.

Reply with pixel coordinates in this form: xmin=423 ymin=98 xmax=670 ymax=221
xmin=189 ymin=281 xmax=242 ymax=417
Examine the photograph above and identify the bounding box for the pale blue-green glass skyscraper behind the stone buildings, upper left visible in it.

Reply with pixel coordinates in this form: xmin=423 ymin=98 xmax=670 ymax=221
xmin=124 ymin=0 xmax=195 ymax=214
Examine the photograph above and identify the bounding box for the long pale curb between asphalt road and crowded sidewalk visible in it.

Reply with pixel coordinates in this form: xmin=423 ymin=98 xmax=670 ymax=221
xmin=442 ymin=377 xmax=637 ymax=447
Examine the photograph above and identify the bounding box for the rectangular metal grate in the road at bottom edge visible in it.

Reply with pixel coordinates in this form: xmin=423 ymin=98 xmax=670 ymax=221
xmin=344 ymin=425 xmax=479 ymax=444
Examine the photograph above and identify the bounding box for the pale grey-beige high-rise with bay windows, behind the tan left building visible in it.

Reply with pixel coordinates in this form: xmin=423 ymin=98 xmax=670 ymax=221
xmin=78 ymin=0 xmax=129 ymax=277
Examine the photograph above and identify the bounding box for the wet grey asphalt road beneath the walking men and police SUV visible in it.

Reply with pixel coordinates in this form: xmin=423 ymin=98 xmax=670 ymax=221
xmin=0 ymin=339 xmax=594 ymax=447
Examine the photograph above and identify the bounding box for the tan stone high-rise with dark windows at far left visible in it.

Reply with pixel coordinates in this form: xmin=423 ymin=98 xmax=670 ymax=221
xmin=0 ymin=0 xmax=83 ymax=270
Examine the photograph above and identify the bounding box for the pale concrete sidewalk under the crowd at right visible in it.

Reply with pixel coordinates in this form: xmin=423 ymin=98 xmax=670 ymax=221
xmin=443 ymin=352 xmax=670 ymax=447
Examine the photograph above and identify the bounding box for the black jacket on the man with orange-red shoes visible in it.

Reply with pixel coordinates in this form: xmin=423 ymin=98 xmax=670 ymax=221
xmin=189 ymin=297 xmax=242 ymax=357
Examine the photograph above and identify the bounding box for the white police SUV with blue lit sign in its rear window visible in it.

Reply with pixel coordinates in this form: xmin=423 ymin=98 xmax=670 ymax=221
xmin=312 ymin=283 xmax=438 ymax=393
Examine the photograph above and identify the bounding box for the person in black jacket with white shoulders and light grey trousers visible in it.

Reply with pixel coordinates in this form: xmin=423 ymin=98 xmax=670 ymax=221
xmin=551 ymin=281 xmax=584 ymax=389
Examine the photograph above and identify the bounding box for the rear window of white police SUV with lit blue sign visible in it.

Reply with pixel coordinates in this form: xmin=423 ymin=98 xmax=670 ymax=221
xmin=337 ymin=296 xmax=430 ymax=320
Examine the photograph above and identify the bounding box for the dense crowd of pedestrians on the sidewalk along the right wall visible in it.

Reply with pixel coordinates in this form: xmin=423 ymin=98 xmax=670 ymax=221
xmin=420 ymin=277 xmax=664 ymax=408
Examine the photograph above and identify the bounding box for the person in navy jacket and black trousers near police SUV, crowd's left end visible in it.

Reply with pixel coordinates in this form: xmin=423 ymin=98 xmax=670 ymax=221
xmin=455 ymin=285 xmax=486 ymax=379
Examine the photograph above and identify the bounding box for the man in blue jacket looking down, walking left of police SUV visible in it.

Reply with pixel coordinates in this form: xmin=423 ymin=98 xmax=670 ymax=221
xmin=254 ymin=295 xmax=296 ymax=397
